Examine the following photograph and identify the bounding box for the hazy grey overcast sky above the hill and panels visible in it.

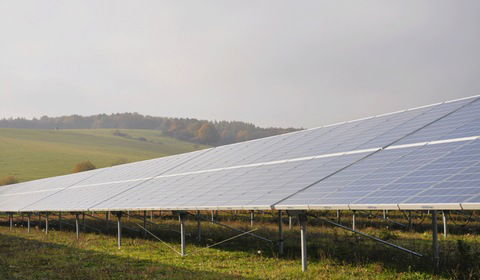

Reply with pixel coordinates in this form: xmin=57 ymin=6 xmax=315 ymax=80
xmin=0 ymin=0 xmax=480 ymax=128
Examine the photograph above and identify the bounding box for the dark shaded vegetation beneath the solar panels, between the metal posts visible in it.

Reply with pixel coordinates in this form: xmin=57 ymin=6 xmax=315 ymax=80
xmin=0 ymin=212 xmax=480 ymax=279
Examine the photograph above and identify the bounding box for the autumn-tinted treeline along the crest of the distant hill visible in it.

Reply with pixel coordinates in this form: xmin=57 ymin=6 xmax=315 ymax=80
xmin=0 ymin=113 xmax=298 ymax=146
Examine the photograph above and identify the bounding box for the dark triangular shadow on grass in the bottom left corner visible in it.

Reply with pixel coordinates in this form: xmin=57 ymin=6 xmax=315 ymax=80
xmin=0 ymin=231 xmax=245 ymax=280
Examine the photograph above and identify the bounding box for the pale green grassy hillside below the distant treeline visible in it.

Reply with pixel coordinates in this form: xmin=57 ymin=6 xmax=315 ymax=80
xmin=0 ymin=128 xmax=206 ymax=181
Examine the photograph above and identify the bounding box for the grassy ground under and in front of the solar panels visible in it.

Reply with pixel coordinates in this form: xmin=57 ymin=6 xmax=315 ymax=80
xmin=0 ymin=212 xmax=480 ymax=279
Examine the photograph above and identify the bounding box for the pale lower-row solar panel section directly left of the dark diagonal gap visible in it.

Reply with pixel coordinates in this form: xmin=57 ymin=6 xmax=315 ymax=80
xmin=91 ymin=151 xmax=364 ymax=210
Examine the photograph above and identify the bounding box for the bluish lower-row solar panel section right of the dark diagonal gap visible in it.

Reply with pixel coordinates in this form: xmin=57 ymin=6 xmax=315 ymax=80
xmin=279 ymin=137 xmax=480 ymax=209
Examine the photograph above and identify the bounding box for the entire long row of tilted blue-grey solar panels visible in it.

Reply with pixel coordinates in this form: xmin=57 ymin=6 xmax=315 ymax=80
xmin=0 ymin=97 xmax=480 ymax=212
